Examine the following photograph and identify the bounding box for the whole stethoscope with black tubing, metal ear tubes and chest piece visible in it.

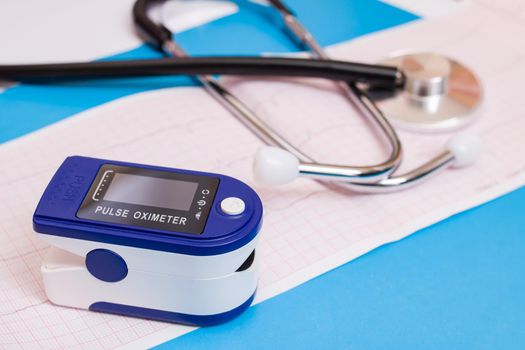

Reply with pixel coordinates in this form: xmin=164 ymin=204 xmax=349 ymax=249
xmin=0 ymin=0 xmax=482 ymax=192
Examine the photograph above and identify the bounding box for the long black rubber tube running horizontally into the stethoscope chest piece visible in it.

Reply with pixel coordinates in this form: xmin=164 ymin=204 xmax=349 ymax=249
xmin=0 ymin=57 xmax=399 ymax=88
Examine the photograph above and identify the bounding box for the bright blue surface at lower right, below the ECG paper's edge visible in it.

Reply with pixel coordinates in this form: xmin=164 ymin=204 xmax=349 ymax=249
xmin=156 ymin=188 xmax=525 ymax=350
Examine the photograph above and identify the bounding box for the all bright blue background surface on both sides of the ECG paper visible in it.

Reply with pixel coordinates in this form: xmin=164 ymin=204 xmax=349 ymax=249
xmin=0 ymin=0 xmax=525 ymax=349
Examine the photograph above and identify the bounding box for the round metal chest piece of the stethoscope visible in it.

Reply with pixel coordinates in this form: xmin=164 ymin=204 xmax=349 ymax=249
xmin=371 ymin=53 xmax=482 ymax=132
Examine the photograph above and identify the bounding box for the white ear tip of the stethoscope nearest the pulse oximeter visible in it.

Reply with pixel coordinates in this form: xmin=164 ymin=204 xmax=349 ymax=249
xmin=253 ymin=146 xmax=299 ymax=185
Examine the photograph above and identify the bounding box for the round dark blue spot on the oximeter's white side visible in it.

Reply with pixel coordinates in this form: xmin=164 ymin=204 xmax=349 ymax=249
xmin=86 ymin=249 xmax=128 ymax=282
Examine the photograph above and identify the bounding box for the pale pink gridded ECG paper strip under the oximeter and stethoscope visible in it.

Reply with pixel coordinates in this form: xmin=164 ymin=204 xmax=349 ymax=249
xmin=0 ymin=0 xmax=525 ymax=349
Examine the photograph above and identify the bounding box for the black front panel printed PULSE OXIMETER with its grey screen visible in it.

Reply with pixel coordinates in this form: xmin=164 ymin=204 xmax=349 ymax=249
xmin=77 ymin=164 xmax=219 ymax=234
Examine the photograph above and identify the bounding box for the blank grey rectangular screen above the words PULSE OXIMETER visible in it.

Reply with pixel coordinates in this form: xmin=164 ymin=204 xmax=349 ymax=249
xmin=103 ymin=173 xmax=199 ymax=211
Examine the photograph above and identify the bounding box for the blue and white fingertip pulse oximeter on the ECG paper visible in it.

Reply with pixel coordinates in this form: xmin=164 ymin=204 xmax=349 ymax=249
xmin=33 ymin=156 xmax=263 ymax=326
